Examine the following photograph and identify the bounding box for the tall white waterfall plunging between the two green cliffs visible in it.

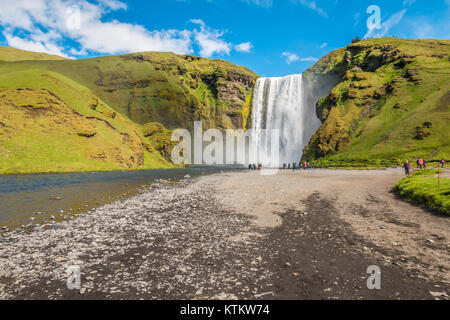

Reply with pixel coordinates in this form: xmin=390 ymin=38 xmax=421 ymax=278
xmin=252 ymin=75 xmax=321 ymax=166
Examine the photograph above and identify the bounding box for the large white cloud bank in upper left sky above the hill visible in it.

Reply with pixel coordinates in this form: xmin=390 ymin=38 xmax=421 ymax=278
xmin=0 ymin=0 xmax=246 ymax=57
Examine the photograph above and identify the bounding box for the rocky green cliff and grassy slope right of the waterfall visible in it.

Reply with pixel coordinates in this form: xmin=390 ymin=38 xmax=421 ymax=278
xmin=303 ymin=38 xmax=450 ymax=165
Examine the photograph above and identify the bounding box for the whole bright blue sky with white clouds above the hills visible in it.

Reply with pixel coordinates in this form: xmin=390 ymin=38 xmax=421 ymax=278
xmin=0 ymin=0 xmax=450 ymax=76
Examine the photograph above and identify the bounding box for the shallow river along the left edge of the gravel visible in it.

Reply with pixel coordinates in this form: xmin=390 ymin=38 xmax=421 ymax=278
xmin=0 ymin=167 xmax=236 ymax=233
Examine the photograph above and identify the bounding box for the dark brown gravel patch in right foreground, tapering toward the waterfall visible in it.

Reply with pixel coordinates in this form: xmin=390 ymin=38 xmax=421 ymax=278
xmin=263 ymin=193 xmax=445 ymax=299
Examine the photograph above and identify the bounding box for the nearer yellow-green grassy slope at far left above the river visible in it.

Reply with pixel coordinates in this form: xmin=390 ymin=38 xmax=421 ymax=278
xmin=0 ymin=69 xmax=172 ymax=174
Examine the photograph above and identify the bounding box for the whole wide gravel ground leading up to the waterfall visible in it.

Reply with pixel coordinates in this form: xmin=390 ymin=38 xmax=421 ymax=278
xmin=0 ymin=170 xmax=450 ymax=299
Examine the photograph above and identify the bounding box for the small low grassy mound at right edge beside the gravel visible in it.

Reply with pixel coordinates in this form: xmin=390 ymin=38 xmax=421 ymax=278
xmin=394 ymin=170 xmax=450 ymax=215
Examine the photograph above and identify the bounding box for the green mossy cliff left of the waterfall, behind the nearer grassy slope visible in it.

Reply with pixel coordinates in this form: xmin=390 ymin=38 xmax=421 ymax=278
xmin=48 ymin=52 xmax=258 ymax=129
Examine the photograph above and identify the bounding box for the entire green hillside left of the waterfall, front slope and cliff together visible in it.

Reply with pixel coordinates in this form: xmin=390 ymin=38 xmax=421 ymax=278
xmin=0 ymin=47 xmax=257 ymax=173
